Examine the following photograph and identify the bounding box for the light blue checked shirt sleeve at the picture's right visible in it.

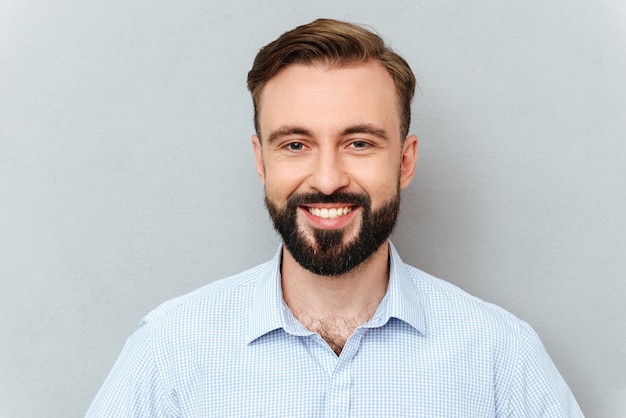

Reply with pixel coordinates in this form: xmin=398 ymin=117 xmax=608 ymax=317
xmin=506 ymin=322 xmax=583 ymax=418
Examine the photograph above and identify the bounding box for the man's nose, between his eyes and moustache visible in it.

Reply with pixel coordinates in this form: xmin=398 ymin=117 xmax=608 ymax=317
xmin=308 ymin=148 xmax=350 ymax=195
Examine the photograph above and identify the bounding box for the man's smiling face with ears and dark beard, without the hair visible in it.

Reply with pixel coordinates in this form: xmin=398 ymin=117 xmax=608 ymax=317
xmin=253 ymin=61 xmax=417 ymax=275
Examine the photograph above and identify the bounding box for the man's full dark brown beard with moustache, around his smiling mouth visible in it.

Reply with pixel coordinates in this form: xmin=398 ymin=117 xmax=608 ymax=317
xmin=265 ymin=190 xmax=400 ymax=276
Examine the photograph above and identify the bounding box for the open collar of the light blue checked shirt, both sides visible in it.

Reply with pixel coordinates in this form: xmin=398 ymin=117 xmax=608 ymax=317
xmin=247 ymin=242 xmax=426 ymax=343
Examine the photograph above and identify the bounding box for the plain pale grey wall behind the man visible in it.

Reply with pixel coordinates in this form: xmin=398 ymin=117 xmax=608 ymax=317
xmin=0 ymin=0 xmax=626 ymax=418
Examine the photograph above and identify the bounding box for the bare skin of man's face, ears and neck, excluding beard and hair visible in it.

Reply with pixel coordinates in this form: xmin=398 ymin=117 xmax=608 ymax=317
xmin=252 ymin=61 xmax=417 ymax=353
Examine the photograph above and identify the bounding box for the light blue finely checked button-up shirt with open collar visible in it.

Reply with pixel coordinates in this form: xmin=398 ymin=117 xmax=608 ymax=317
xmin=87 ymin=246 xmax=582 ymax=418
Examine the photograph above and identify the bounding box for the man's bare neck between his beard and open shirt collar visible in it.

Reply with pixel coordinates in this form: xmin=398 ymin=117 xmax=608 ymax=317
xmin=281 ymin=242 xmax=389 ymax=338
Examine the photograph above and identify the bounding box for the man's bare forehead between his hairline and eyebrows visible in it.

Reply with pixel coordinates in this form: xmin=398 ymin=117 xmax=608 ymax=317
xmin=258 ymin=61 xmax=400 ymax=136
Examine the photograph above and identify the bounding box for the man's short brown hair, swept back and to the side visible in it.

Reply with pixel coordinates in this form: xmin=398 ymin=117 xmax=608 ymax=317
xmin=248 ymin=19 xmax=416 ymax=141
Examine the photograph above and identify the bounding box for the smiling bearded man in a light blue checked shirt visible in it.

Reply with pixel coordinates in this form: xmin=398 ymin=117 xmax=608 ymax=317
xmin=88 ymin=20 xmax=582 ymax=417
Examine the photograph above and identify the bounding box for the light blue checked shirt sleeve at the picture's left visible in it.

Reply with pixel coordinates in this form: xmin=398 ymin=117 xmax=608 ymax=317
xmin=86 ymin=323 xmax=177 ymax=418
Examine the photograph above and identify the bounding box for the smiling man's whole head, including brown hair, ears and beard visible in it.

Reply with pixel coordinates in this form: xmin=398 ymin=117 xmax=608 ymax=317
xmin=248 ymin=20 xmax=417 ymax=276
